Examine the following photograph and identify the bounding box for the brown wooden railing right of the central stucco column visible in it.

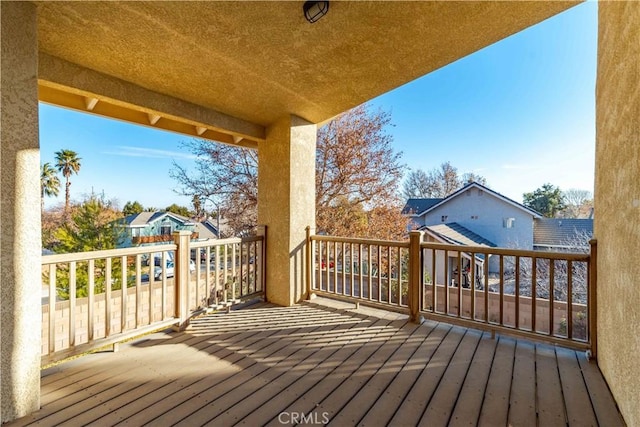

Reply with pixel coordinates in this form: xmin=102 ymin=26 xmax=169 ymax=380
xmin=307 ymin=232 xmax=596 ymax=357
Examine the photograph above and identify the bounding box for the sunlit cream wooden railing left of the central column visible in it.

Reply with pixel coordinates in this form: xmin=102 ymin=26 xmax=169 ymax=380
xmin=42 ymin=230 xmax=265 ymax=365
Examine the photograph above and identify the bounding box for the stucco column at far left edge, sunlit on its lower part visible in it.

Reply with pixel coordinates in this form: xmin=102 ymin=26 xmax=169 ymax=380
xmin=0 ymin=1 xmax=42 ymax=422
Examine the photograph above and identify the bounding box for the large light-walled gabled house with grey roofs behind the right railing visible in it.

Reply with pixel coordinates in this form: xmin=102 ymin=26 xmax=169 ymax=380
xmin=402 ymin=182 xmax=593 ymax=282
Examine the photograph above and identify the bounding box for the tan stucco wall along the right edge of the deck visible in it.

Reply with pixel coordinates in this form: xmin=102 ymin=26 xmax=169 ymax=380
xmin=594 ymin=2 xmax=640 ymax=426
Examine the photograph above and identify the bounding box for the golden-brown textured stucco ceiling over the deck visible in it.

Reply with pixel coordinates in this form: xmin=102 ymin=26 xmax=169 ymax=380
xmin=33 ymin=1 xmax=576 ymax=135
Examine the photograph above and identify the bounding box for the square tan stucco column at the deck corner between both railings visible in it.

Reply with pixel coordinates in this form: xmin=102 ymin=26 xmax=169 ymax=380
xmin=258 ymin=116 xmax=317 ymax=306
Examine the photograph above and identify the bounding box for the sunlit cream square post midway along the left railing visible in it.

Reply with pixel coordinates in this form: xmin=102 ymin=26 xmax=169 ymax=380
xmin=173 ymin=230 xmax=191 ymax=331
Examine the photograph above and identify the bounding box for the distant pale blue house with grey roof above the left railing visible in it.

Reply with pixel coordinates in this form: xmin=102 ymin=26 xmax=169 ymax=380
xmin=121 ymin=212 xmax=218 ymax=247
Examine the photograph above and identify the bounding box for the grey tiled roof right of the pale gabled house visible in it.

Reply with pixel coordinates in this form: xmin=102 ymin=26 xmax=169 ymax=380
xmin=533 ymin=218 xmax=593 ymax=252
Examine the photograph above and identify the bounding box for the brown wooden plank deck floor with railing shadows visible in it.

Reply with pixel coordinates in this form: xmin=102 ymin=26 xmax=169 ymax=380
xmin=9 ymin=303 xmax=624 ymax=427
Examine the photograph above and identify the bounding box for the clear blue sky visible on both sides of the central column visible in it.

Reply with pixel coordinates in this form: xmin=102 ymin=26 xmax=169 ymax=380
xmin=40 ymin=2 xmax=597 ymax=208
